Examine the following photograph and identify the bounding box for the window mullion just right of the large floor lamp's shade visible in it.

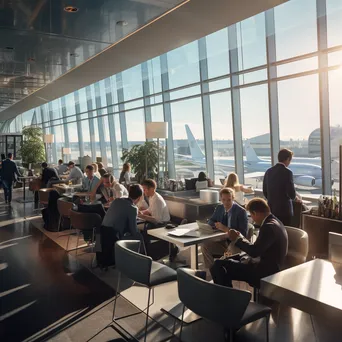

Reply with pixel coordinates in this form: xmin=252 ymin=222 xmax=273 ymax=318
xmin=159 ymin=54 xmax=176 ymax=178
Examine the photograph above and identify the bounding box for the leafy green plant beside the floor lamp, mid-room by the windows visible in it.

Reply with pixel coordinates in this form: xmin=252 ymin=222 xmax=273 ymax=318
xmin=121 ymin=141 xmax=158 ymax=183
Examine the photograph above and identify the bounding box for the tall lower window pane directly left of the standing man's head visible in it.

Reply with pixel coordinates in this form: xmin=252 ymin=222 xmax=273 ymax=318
xmin=240 ymin=84 xmax=271 ymax=188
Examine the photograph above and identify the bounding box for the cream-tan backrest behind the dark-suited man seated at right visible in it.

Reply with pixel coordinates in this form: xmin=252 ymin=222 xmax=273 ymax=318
xmin=285 ymin=226 xmax=309 ymax=266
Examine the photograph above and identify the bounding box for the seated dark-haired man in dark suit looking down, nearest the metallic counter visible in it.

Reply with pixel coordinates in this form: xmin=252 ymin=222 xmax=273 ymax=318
xmin=210 ymin=198 xmax=288 ymax=287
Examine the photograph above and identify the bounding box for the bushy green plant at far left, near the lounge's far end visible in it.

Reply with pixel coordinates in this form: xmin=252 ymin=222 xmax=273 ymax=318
xmin=20 ymin=126 xmax=45 ymax=167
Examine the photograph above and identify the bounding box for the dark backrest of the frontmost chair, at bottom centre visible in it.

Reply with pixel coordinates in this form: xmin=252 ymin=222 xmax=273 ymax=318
xmin=177 ymin=268 xmax=251 ymax=329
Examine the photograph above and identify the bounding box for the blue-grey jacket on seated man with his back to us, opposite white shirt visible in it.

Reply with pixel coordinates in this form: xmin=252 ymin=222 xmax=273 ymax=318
xmin=102 ymin=198 xmax=140 ymax=240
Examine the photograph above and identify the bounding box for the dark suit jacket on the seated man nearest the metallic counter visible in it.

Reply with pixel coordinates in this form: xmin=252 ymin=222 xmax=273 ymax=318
xmin=235 ymin=214 xmax=288 ymax=278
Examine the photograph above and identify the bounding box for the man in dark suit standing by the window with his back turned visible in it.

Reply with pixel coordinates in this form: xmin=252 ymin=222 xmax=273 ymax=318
xmin=263 ymin=149 xmax=296 ymax=226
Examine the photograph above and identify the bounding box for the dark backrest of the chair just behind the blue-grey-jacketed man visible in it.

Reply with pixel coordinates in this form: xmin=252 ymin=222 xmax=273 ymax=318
xmin=115 ymin=240 xmax=152 ymax=286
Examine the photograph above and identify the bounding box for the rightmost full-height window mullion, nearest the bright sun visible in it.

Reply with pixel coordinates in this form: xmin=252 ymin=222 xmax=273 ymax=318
xmin=316 ymin=0 xmax=332 ymax=195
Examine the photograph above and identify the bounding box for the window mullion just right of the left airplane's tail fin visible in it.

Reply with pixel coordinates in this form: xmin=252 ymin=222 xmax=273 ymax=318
xmin=198 ymin=38 xmax=215 ymax=181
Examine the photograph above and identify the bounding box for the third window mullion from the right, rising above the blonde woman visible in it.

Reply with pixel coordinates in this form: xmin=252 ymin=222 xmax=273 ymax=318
xmin=228 ymin=25 xmax=244 ymax=183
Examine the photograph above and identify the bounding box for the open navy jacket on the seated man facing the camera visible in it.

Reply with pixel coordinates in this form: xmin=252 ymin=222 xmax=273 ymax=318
xmin=208 ymin=202 xmax=248 ymax=236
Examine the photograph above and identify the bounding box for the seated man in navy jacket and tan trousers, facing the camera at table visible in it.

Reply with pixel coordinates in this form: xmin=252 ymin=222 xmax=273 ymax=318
xmin=201 ymin=188 xmax=248 ymax=269
